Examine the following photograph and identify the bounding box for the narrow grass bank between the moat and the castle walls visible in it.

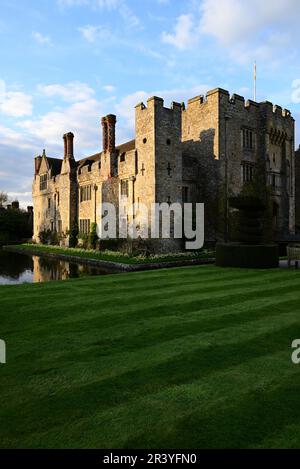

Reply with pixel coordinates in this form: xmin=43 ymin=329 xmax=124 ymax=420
xmin=14 ymin=244 xmax=215 ymax=264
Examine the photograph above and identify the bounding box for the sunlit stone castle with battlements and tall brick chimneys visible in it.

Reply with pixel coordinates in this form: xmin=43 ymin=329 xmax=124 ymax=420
xmin=33 ymin=88 xmax=295 ymax=250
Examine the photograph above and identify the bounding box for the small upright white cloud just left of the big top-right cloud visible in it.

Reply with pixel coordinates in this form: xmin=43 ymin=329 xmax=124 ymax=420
xmin=162 ymin=15 xmax=196 ymax=50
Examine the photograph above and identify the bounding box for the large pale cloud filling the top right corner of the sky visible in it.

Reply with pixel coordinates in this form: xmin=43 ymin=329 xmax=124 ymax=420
xmin=199 ymin=0 xmax=300 ymax=62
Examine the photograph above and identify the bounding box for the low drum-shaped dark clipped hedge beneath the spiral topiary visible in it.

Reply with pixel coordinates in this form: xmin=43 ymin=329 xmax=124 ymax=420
xmin=216 ymin=243 xmax=279 ymax=269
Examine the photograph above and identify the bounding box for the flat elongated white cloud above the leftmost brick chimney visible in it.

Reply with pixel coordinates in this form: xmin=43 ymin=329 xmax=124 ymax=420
xmin=38 ymin=81 xmax=95 ymax=103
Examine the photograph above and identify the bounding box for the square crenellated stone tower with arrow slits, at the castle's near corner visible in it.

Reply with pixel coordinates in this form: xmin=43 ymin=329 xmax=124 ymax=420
xmin=134 ymin=96 xmax=182 ymax=250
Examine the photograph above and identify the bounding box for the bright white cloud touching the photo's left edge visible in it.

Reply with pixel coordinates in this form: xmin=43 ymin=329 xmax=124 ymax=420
xmin=0 ymin=91 xmax=32 ymax=117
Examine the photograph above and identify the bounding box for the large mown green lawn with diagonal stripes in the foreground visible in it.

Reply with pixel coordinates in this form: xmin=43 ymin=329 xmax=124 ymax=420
xmin=0 ymin=266 xmax=300 ymax=448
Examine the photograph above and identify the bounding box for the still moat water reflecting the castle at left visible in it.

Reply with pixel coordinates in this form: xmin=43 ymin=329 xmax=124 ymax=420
xmin=0 ymin=248 xmax=114 ymax=285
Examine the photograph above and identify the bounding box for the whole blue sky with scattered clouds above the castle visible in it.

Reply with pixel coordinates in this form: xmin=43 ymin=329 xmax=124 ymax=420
xmin=0 ymin=0 xmax=300 ymax=205
